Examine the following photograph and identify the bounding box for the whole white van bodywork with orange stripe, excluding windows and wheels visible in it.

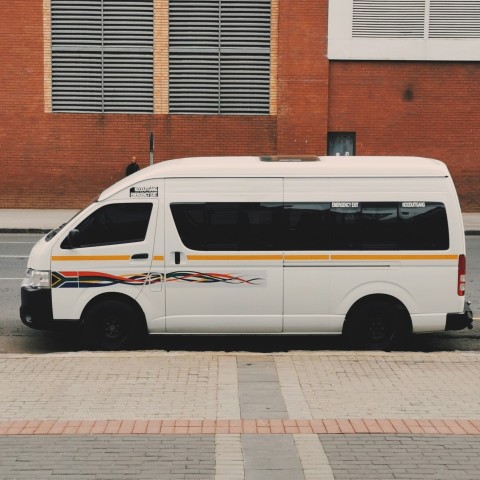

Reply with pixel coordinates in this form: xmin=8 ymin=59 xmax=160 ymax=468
xmin=21 ymin=157 xmax=465 ymax=346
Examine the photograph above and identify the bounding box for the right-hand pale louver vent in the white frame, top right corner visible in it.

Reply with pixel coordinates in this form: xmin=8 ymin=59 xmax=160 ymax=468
xmin=429 ymin=0 xmax=480 ymax=38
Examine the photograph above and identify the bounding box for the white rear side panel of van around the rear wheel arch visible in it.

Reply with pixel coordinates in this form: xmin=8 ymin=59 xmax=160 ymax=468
xmin=284 ymin=172 xmax=465 ymax=333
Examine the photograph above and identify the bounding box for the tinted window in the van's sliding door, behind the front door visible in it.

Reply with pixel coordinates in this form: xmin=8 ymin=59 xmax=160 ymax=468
xmin=170 ymin=202 xmax=283 ymax=251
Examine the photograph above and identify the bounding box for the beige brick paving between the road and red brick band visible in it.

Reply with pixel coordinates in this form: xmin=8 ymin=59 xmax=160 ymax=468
xmin=0 ymin=352 xmax=480 ymax=420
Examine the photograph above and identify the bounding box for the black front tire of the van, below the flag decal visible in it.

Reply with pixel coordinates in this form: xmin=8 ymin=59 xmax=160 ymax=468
xmin=83 ymin=299 xmax=144 ymax=350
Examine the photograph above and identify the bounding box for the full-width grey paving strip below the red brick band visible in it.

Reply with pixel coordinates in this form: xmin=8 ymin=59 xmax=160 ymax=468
xmin=0 ymin=434 xmax=480 ymax=480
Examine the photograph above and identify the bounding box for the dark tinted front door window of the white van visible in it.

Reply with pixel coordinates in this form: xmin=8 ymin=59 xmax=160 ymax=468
xmin=62 ymin=203 xmax=152 ymax=248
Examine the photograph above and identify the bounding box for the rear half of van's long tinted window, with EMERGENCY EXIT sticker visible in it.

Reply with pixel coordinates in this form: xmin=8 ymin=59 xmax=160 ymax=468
xmin=284 ymin=202 xmax=449 ymax=250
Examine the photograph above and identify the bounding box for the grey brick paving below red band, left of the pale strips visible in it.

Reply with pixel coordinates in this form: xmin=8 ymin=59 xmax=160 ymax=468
xmin=0 ymin=435 xmax=215 ymax=480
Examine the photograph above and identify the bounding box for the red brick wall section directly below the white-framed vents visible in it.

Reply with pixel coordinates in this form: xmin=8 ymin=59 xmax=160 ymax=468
xmin=328 ymin=62 xmax=480 ymax=211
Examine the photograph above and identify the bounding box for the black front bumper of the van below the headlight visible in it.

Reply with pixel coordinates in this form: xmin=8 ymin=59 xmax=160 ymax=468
xmin=20 ymin=287 xmax=53 ymax=330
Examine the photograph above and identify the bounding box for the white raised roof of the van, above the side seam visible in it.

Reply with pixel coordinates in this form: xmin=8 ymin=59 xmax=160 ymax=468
xmin=99 ymin=155 xmax=450 ymax=200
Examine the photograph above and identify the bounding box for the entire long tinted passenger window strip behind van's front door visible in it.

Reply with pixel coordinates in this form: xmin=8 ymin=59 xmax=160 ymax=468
xmin=170 ymin=201 xmax=449 ymax=251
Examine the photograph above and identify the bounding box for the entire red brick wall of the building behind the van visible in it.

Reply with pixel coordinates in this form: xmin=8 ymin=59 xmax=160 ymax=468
xmin=0 ymin=0 xmax=480 ymax=211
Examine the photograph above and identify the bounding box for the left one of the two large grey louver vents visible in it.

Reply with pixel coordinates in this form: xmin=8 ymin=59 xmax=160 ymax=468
xmin=51 ymin=0 xmax=153 ymax=113
